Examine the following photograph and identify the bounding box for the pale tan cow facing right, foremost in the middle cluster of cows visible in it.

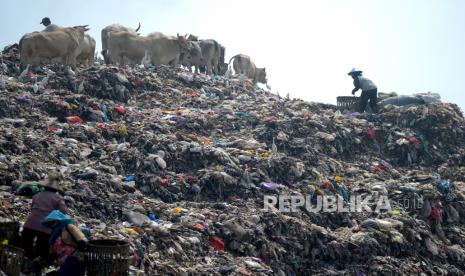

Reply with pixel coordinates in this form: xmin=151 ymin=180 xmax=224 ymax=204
xmin=108 ymin=32 xmax=201 ymax=66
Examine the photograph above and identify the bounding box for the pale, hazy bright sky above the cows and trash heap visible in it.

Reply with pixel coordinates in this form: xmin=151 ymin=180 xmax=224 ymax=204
xmin=0 ymin=0 xmax=465 ymax=110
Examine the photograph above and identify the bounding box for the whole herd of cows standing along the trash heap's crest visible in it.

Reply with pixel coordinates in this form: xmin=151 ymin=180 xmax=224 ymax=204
xmin=19 ymin=18 xmax=267 ymax=83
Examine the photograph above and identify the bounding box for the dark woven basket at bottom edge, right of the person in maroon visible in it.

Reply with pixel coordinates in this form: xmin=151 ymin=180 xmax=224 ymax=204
xmin=86 ymin=240 xmax=130 ymax=275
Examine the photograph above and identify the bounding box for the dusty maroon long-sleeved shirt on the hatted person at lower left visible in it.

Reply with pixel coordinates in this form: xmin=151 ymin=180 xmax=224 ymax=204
xmin=24 ymin=191 xmax=68 ymax=234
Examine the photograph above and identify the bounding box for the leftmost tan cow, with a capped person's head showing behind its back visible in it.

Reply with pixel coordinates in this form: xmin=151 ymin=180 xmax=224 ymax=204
xmin=20 ymin=25 xmax=89 ymax=66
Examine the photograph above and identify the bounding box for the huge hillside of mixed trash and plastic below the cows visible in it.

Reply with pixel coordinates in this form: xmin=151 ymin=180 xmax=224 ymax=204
xmin=0 ymin=46 xmax=465 ymax=275
